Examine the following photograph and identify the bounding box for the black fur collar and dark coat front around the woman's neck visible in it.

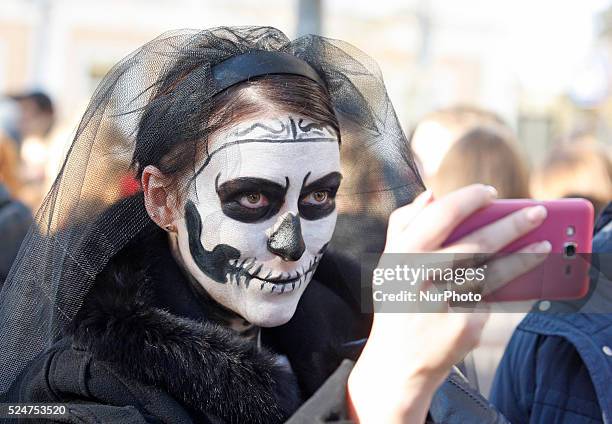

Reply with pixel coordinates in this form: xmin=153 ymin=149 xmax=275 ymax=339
xmin=68 ymin=217 xmax=371 ymax=423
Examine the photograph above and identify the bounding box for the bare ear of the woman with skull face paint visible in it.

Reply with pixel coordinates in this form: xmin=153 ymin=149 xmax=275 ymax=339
xmin=141 ymin=165 xmax=177 ymax=229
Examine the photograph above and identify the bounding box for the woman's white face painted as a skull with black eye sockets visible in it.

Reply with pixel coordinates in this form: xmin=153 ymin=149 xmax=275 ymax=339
xmin=175 ymin=114 xmax=341 ymax=327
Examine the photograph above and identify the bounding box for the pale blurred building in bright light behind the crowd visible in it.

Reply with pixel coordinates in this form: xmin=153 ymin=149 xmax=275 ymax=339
xmin=0 ymin=0 xmax=612 ymax=171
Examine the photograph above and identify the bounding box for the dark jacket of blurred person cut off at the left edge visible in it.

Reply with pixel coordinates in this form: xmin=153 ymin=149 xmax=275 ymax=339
xmin=0 ymin=181 xmax=32 ymax=289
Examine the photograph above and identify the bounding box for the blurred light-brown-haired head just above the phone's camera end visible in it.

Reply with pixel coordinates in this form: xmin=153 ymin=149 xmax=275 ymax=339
xmin=531 ymin=142 xmax=612 ymax=215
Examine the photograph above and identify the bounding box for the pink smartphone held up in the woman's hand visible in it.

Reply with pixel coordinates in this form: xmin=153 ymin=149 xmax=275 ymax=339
xmin=444 ymin=198 xmax=594 ymax=302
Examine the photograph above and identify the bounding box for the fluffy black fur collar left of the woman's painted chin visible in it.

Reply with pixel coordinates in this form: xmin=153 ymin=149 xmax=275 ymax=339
xmin=70 ymin=225 xmax=301 ymax=423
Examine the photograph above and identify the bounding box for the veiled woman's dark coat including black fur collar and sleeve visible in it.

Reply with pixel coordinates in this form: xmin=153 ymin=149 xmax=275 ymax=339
xmin=4 ymin=202 xmax=505 ymax=424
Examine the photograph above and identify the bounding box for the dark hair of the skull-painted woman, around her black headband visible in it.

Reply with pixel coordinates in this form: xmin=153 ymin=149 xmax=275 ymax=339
xmin=132 ymin=69 xmax=340 ymax=187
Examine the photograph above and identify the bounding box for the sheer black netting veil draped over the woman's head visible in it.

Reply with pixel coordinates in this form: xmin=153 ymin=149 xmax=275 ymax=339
xmin=0 ymin=27 xmax=423 ymax=394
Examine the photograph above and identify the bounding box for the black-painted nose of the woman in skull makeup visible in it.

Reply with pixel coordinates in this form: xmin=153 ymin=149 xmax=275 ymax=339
xmin=268 ymin=212 xmax=306 ymax=261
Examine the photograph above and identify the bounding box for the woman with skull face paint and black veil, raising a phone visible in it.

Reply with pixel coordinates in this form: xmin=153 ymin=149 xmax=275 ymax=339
xmin=0 ymin=27 xmax=547 ymax=424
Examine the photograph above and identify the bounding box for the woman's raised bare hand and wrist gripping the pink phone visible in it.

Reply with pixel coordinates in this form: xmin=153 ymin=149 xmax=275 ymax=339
xmin=348 ymin=184 xmax=550 ymax=423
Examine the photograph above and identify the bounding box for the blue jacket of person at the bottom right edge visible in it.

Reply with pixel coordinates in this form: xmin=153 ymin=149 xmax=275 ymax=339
xmin=491 ymin=203 xmax=612 ymax=424
